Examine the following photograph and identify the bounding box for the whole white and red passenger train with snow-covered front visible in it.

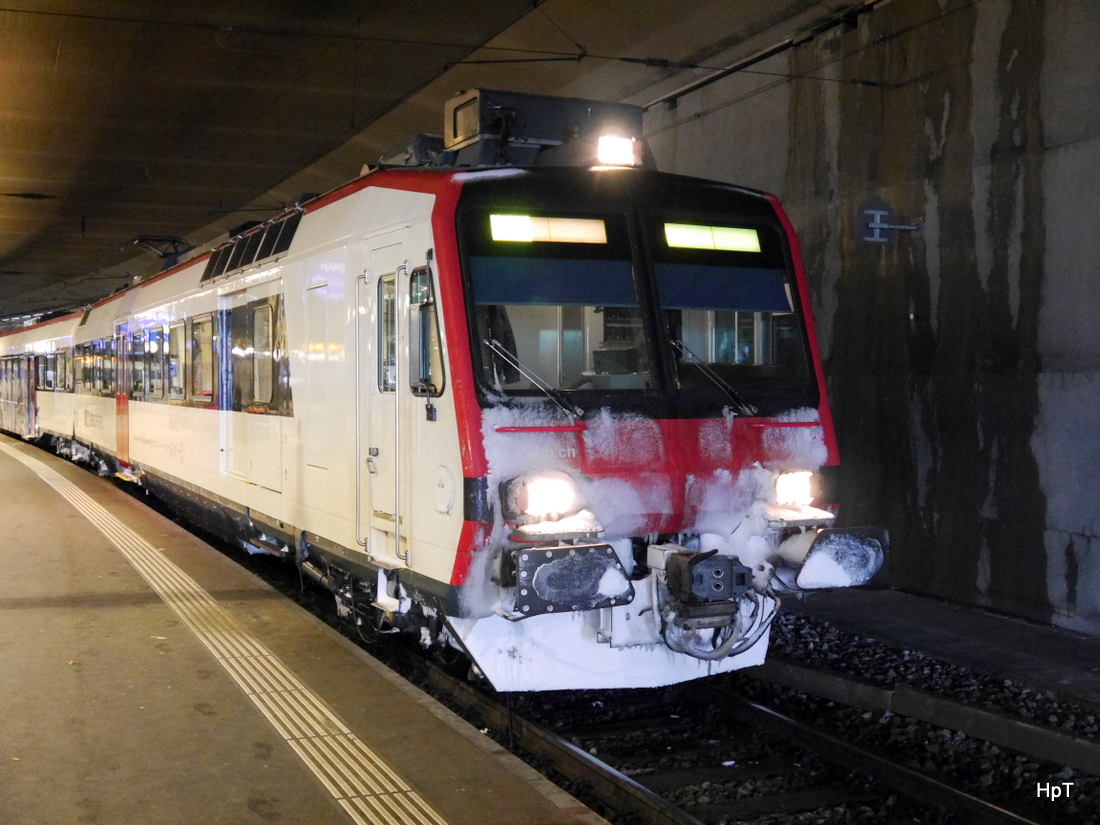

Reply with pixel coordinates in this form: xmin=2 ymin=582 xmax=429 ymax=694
xmin=0 ymin=89 xmax=888 ymax=692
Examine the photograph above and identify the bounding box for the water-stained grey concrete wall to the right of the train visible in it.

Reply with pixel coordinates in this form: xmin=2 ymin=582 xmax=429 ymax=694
xmin=647 ymin=0 xmax=1100 ymax=633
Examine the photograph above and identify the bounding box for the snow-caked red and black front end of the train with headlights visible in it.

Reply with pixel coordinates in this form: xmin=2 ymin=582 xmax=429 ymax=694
xmin=433 ymin=169 xmax=886 ymax=690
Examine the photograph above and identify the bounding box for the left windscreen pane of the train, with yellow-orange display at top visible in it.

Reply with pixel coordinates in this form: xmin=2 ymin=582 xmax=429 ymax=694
xmin=468 ymin=210 xmax=651 ymax=392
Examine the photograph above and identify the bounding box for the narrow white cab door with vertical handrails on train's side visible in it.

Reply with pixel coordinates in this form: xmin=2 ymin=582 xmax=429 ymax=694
xmin=356 ymin=229 xmax=410 ymax=564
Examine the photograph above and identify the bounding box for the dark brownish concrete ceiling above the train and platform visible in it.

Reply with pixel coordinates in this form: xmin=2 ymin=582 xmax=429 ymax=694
xmin=0 ymin=0 xmax=867 ymax=317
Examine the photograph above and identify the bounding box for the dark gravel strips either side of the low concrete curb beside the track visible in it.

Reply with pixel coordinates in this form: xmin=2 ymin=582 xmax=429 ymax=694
xmin=717 ymin=614 xmax=1100 ymax=825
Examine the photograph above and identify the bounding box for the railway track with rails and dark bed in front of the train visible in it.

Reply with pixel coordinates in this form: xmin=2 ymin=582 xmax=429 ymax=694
xmin=428 ymin=668 xmax=1056 ymax=825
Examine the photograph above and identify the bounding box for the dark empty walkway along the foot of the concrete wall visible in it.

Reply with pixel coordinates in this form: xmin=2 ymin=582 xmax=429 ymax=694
xmin=782 ymin=589 xmax=1100 ymax=711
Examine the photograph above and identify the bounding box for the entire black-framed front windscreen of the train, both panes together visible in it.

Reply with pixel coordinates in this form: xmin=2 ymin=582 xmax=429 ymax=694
xmin=459 ymin=187 xmax=817 ymax=417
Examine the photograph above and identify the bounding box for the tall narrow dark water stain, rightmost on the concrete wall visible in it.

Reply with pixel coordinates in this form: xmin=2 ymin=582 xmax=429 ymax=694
xmin=982 ymin=0 xmax=1051 ymax=618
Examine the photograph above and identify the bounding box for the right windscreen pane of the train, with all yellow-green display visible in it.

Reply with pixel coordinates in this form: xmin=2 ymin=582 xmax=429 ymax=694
xmin=650 ymin=220 xmax=810 ymax=391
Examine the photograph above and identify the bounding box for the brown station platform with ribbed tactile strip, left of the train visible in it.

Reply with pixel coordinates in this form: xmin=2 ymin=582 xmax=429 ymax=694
xmin=0 ymin=436 xmax=606 ymax=825
